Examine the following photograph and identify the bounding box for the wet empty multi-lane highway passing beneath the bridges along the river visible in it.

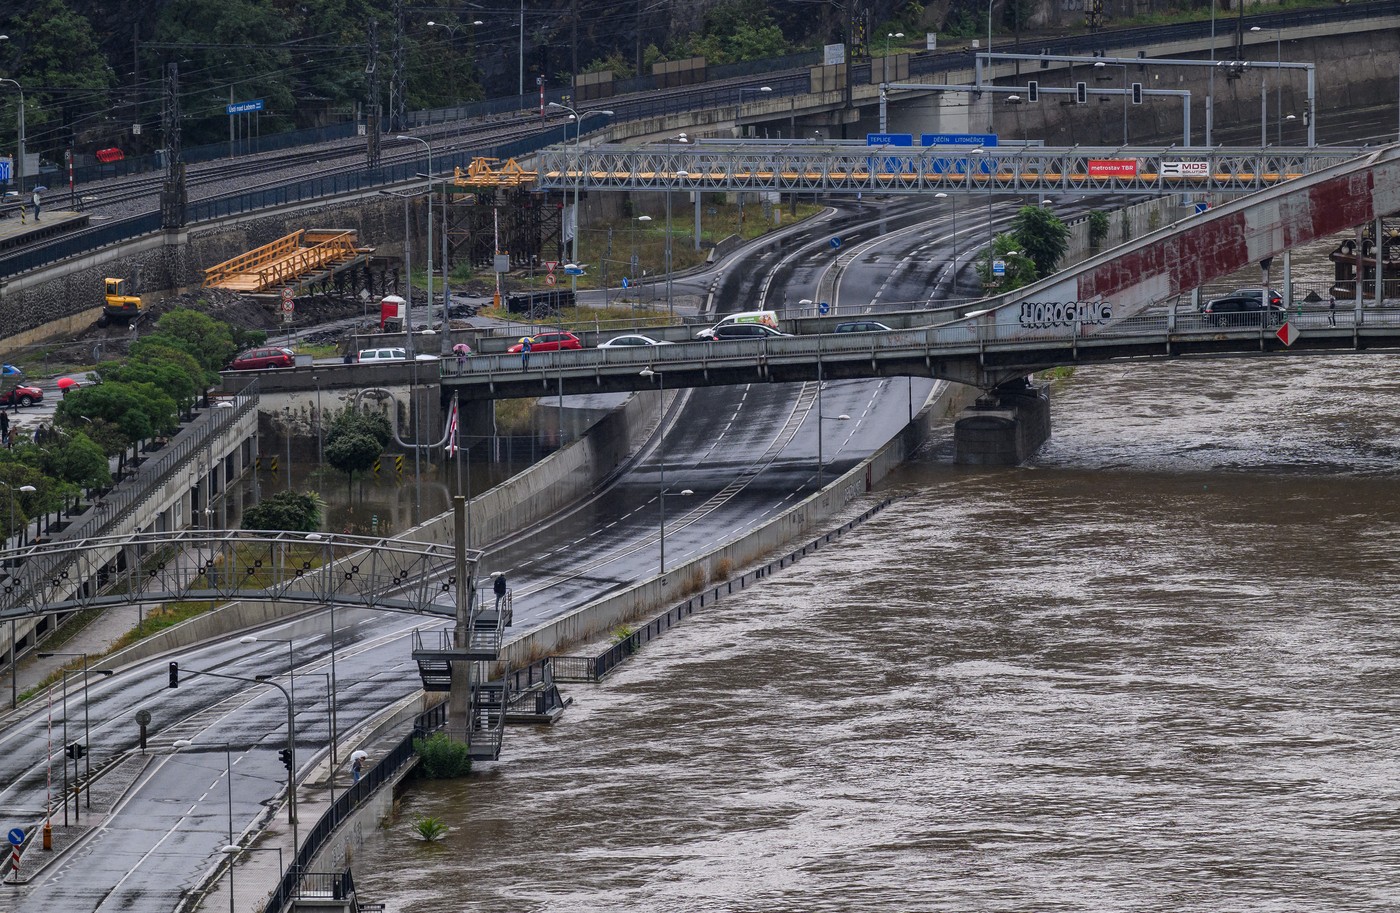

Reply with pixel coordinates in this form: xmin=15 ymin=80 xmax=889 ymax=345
xmin=0 ymin=202 xmax=985 ymax=913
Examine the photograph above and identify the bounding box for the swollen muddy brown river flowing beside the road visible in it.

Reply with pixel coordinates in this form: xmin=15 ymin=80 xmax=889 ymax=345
xmin=353 ymin=356 xmax=1400 ymax=913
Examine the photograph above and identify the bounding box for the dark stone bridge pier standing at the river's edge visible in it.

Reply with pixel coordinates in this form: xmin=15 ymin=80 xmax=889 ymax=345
xmin=953 ymin=378 xmax=1050 ymax=466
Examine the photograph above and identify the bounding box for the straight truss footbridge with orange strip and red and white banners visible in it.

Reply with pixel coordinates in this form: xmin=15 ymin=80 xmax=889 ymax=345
xmin=539 ymin=140 xmax=1373 ymax=195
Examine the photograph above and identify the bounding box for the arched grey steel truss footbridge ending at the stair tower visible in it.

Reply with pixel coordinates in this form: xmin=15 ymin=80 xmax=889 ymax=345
xmin=0 ymin=529 xmax=480 ymax=619
